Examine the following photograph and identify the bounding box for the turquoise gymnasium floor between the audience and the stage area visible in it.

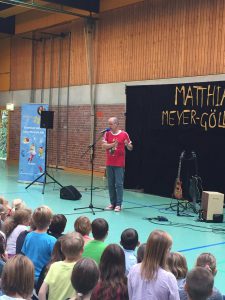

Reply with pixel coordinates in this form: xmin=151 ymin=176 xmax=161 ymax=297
xmin=0 ymin=161 xmax=225 ymax=294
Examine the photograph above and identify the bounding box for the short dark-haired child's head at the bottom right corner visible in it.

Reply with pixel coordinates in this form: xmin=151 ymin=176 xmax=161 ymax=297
xmin=185 ymin=267 xmax=214 ymax=300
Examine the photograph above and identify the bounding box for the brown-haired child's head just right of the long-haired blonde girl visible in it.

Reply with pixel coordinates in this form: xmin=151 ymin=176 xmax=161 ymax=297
xmin=167 ymin=252 xmax=188 ymax=279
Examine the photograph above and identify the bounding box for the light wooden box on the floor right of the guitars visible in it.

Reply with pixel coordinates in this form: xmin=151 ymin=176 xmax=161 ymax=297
xmin=201 ymin=191 xmax=224 ymax=222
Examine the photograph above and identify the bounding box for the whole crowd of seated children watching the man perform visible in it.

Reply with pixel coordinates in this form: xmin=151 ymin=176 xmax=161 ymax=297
xmin=0 ymin=197 xmax=223 ymax=300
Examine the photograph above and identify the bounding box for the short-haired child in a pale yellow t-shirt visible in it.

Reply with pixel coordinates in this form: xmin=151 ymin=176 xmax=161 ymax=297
xmin=38 ymin=232 xmax=84 ymax=300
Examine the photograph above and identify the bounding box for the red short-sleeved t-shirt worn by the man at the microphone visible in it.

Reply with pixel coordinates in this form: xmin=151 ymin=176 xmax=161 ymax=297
xmin=103 ymin=130 xmax=131 ymax=167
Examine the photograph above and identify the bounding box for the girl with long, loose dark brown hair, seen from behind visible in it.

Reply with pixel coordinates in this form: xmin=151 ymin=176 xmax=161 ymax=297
xmin=91 ymin=244 xmax=128 ymax=300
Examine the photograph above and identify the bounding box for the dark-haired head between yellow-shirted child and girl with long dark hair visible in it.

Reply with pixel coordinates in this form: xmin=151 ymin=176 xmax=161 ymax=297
xmin=71 ymin=258 xmax=99 ymax=299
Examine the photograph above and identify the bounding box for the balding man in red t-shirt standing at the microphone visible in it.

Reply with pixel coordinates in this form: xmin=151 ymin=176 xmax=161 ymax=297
xmin=102 ymin=117 xmax=133 ymax=212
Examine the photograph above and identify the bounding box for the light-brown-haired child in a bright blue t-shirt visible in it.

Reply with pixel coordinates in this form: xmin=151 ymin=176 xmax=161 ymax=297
xmin=21 ymin=205 xmax=56 ymax=282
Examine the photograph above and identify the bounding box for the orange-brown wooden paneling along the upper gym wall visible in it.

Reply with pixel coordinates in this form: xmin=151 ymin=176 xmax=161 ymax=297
xmin=8 ymin=0 xmax=225 ymax=89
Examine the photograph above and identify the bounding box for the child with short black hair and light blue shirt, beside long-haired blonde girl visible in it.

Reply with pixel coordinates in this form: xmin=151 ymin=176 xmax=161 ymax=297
xmin=120 ymin=228 xmax=140 ymax=275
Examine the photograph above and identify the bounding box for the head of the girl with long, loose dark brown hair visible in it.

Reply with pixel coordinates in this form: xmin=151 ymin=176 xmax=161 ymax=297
xmin=99 ymin=244 xmax=125 ymax=281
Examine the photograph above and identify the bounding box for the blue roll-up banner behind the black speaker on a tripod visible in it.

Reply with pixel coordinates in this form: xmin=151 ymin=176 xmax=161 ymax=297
xmin=18 ymin=104 xmax=48 ymax=182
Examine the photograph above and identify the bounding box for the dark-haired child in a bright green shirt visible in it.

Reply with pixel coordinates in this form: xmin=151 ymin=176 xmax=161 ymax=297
xmin=83 ymin=218 xmax=109 ymax=264
